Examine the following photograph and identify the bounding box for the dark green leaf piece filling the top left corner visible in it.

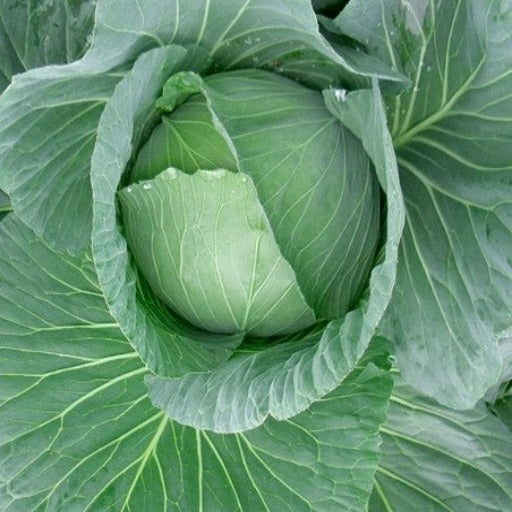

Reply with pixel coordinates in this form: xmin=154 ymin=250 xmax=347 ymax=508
xmin=0 ymin=0 xmax=95 ymax=92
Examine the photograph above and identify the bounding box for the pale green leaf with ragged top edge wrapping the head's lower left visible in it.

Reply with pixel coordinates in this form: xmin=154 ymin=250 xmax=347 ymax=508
xmin=119 ymin=168 xmax=315 ymax=336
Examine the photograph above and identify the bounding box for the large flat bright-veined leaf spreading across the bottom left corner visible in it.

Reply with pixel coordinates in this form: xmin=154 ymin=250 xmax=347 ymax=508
xmin=0 ymin=215 xmax=391 ymax=512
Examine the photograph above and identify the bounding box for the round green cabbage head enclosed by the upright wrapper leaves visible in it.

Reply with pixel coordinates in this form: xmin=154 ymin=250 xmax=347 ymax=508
xmin=120 ymin=69 xmax=379 ymax=337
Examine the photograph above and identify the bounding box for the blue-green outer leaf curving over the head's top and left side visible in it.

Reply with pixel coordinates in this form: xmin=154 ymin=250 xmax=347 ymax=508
xmin=0 ymin=0 xmax=399 ymax=254
